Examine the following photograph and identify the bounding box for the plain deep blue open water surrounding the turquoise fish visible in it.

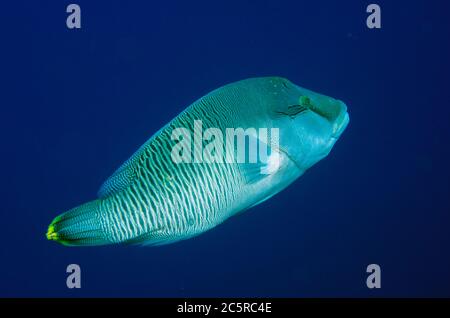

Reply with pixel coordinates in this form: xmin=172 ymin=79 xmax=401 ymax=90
xmin=0 ymin=0 xmax=450 ymax=297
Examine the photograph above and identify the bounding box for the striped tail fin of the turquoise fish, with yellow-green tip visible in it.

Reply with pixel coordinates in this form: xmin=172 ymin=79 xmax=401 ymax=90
xmin=47 ymin=200 xmax=111 ymax=246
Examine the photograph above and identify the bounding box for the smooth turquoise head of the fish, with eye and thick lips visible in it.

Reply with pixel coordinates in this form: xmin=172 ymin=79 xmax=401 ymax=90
xmin=272 ymin=80 xmax=349 ymax=171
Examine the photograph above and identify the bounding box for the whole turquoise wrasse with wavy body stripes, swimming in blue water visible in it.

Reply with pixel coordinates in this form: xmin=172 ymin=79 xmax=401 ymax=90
xmin=46 ymin=77 xmax=349 ymax=246
